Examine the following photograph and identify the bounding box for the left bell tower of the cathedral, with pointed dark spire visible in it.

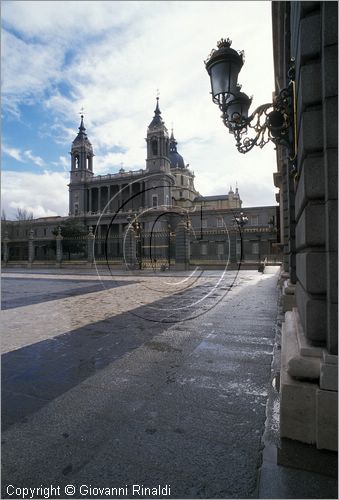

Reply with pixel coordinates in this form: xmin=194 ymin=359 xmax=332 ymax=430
xmin=69 ymin=115 xmax=94 ymax=215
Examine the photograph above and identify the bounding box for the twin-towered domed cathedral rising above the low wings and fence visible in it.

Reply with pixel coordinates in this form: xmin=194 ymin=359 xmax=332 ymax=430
xmin=69 ymin=97 xmax=242 ymax=233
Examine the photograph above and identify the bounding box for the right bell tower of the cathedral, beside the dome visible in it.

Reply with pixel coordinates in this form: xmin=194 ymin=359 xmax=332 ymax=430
xmin=146 ymin=97 xmax=171 ymax=173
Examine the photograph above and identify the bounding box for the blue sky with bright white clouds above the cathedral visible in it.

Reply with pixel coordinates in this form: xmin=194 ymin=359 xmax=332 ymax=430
xmin=1 ymin=0 xmax=276 ymax=219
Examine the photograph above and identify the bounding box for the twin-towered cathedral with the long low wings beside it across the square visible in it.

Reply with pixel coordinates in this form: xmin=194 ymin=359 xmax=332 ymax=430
xmin=3 ymin=98 xmax=279 ymax=265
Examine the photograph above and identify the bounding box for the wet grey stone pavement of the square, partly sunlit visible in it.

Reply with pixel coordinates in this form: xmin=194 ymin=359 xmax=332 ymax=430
xmin=2 ymin=268 xmax=332 ymax=498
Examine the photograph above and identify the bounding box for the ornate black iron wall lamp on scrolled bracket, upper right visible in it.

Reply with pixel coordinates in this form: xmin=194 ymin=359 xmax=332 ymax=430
xmin=205 ymin=38 xmax=296 ymax=159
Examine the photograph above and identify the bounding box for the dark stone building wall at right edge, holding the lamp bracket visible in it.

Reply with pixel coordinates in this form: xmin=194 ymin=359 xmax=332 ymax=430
xmin=272 ymin=2 xmax=338 ymax=458
